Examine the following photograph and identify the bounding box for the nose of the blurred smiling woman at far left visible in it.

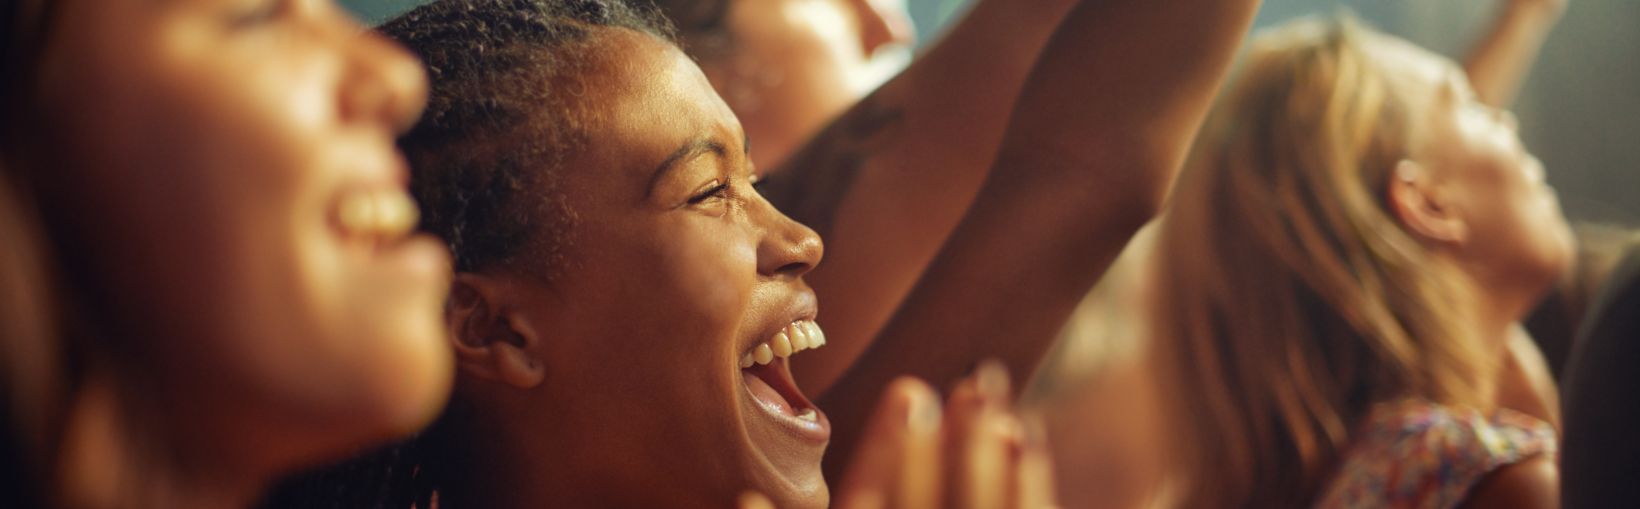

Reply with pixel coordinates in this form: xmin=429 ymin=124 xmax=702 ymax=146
xmin=338 ymin=13 xmax=428 ymax=133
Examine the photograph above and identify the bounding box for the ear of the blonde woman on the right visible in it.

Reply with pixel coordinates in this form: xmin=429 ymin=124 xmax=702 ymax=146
xmin=1387 ymin=159 xmax=1469 ymax=245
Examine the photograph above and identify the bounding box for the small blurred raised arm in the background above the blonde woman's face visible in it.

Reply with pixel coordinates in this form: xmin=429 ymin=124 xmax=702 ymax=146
xmin=1463 ymin=0 xmax=1569 ymax=108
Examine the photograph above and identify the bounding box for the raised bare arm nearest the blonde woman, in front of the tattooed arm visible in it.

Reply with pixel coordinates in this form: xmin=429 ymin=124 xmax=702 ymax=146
xmin=820 ymin=0 xmax=1258 ymax=470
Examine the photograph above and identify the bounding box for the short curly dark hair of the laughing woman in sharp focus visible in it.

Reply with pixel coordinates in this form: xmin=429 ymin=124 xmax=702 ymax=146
xmin=380 ymin=0 xmax=674 ymax=276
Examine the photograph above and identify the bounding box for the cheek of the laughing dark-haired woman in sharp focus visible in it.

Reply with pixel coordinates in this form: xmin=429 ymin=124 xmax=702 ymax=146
xmin=558 ymin=215 xmax=756 ymax=366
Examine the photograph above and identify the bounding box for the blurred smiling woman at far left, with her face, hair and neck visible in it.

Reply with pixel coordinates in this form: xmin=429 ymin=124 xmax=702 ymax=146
xmin=0 ymin=0 xmax=451 ymax=507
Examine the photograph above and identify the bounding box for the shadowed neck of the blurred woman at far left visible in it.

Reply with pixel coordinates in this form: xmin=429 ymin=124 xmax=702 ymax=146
xmin=56 ymin=369 xmax=272 ymax=509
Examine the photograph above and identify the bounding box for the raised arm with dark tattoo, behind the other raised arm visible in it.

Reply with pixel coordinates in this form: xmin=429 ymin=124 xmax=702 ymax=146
xmin=768 ymin=0 xmax=1076 ymax=394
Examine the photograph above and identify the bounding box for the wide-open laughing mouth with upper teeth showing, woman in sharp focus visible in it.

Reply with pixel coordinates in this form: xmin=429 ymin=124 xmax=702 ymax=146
xmin=740 ymin=320 xmax=831 ymax=440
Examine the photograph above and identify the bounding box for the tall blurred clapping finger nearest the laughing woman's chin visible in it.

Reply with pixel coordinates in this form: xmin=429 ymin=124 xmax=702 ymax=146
xmin=836 ymin=378 xmax=940 ymax=509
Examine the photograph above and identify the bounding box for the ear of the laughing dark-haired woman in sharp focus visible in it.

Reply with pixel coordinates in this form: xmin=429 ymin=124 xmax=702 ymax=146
xmin=444 ymin=273 xmax=546 ymax=389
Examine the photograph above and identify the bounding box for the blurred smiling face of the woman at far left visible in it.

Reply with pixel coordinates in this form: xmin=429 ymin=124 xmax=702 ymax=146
xmin=34 ymin=0 xmax=451 ymax=475
